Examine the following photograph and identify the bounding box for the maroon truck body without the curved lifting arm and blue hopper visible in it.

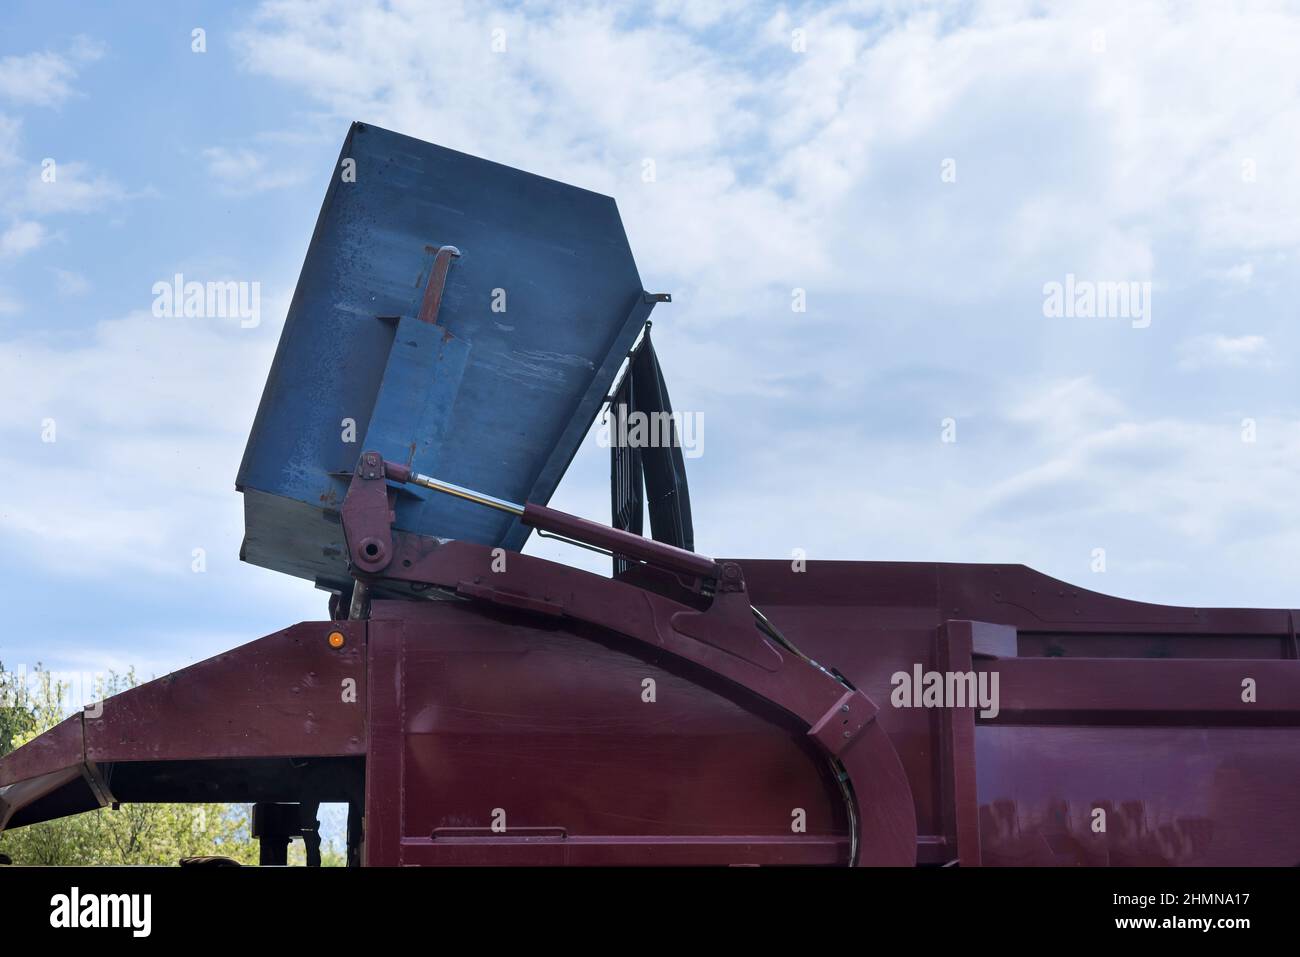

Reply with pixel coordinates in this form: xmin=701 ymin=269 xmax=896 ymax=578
xmin=0 ymin=559 xmax=1300 ymax=866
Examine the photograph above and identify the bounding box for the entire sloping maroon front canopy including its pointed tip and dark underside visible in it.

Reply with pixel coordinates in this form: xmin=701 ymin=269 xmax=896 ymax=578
xmin=0 ymin=622 xmax=367 ymax=828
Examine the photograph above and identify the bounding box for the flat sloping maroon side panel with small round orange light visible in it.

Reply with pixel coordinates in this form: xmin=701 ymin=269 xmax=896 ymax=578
xmin=85 ymin=622 xmax=365 ymax=762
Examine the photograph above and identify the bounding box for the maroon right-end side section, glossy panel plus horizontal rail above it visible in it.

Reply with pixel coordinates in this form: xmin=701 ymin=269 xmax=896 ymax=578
xmin=976 ymin=658 xmax=1300 ymax=866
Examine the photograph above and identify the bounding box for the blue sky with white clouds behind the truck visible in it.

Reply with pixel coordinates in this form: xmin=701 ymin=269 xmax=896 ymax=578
xmin=0 ymin=0 xmax=1300 ymax=677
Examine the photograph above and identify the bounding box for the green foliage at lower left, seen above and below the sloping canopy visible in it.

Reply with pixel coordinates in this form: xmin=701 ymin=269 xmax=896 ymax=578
xmin=0 ymin=664 xmax=271 ymax=865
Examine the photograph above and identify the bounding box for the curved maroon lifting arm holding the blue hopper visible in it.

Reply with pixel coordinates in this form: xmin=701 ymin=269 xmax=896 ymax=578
xmin=342 ymin=452 xmax=917 ymax=866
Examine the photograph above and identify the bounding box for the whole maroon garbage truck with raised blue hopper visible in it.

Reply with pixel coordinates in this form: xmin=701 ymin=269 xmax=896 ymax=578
xmin=0 ymin=124 xmax=1300 ymax=867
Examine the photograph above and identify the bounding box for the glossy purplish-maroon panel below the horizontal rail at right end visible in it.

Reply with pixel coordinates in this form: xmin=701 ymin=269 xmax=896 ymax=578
xmin=976 ymin=724 xmax=1300 ymax=867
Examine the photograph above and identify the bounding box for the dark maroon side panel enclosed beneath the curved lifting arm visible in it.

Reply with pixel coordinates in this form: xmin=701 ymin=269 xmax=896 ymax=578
xmin=367 ymin=602 xmax=849 ymax=865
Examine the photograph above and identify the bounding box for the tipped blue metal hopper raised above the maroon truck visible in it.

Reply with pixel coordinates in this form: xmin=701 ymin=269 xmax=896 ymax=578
xmin=237 ymin=124 xmax=653 ymax=586
